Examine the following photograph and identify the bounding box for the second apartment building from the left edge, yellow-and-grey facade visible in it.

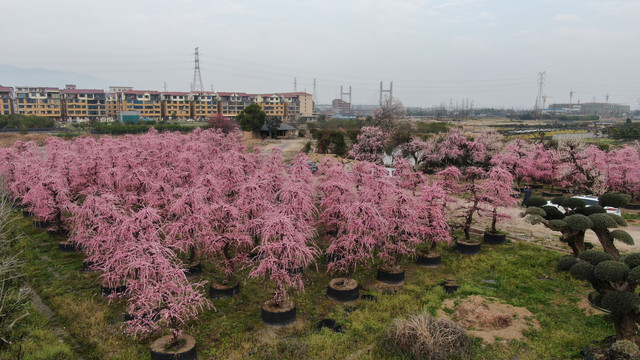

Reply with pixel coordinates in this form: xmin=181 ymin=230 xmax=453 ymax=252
xmin=15 ymin=86 xmax=62 ymax=120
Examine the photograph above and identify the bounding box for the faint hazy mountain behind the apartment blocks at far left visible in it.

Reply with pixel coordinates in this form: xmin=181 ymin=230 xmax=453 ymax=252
xmin=0 ymin=64 xmax=109 ymax=89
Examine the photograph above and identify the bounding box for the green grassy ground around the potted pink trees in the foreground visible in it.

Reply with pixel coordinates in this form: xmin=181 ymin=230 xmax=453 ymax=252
xmin=0 ymin=211 xmax=614 ymax=360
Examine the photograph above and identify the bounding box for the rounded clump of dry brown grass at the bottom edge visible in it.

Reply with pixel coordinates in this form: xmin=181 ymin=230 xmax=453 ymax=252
xmin=386 ymin=314 xmax=471 ymax=360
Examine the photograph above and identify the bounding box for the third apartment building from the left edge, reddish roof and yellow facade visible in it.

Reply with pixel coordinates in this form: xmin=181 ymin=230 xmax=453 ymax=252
xmin=60 ymin=85 xmax=107 ymax=122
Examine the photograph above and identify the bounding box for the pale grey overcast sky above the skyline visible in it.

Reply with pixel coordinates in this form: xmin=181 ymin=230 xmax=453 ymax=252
xmin=0 ymin=0 xmax=640 ymax=109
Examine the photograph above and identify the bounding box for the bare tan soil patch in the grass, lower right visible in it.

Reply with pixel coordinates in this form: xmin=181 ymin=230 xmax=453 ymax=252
xmin=438 ymin=295 xmax=540 ymax=343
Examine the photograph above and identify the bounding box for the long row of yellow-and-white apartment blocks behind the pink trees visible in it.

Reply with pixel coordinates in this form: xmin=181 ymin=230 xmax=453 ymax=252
xmin=0 ymin=85 xmax=313 ymax=121
